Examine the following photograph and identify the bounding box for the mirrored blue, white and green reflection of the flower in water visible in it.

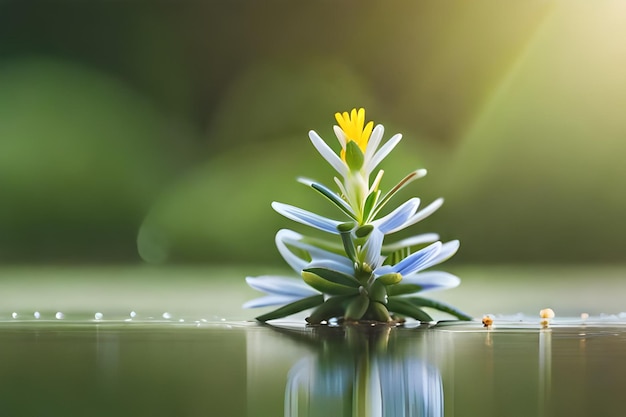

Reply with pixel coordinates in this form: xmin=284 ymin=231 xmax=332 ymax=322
xmin=276 ymin=326 xmax=444 ymax=417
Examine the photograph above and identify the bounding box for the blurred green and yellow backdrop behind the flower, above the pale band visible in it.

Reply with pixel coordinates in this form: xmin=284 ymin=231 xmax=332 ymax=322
xmin=0 ymin=0 xmax=626 ymax=265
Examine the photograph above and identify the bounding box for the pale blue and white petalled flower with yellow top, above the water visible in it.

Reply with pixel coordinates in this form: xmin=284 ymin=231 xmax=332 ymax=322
xmin=245 ymin=109 xmax=469 ymax=323
